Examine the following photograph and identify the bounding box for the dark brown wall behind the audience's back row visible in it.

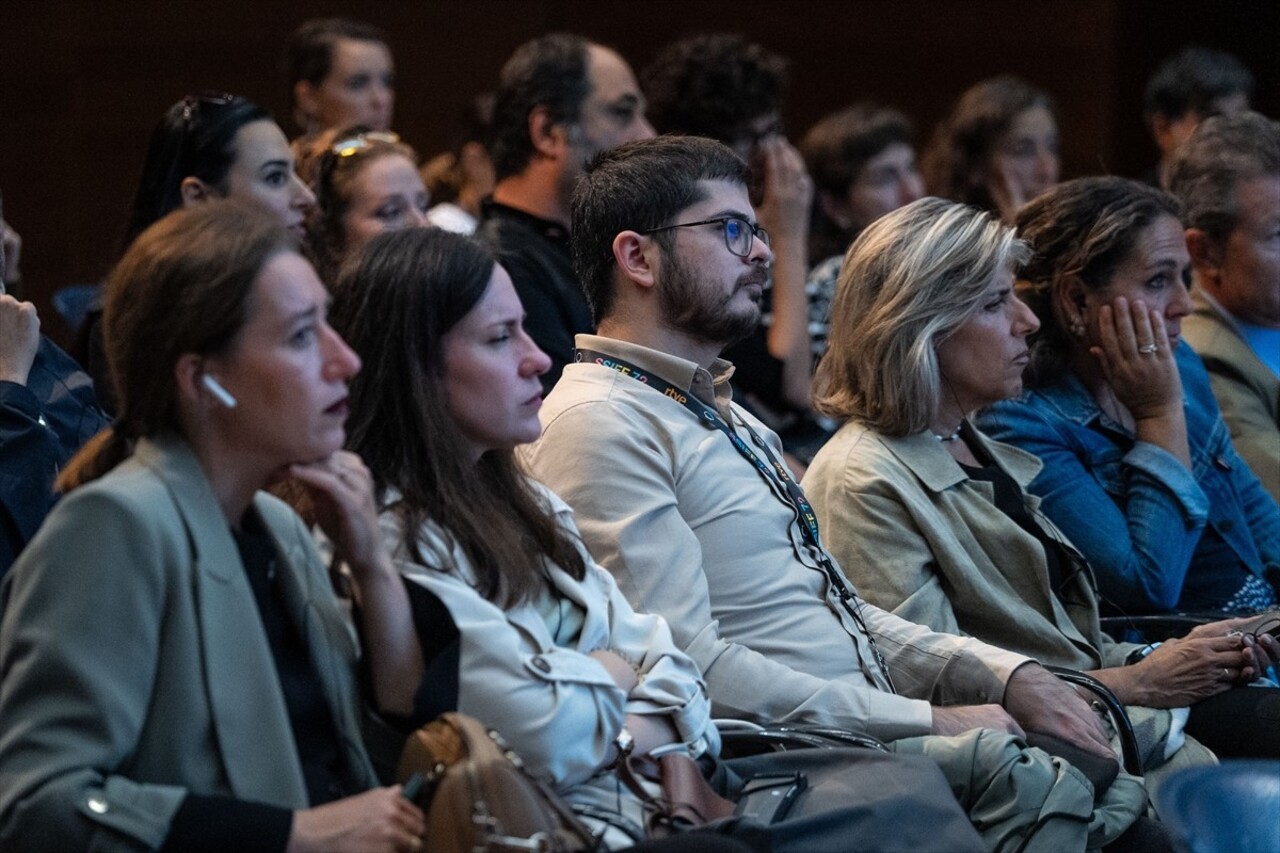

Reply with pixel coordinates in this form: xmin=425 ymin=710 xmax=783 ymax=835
xmin=0 ymin=0 xmax=1280 ymax=348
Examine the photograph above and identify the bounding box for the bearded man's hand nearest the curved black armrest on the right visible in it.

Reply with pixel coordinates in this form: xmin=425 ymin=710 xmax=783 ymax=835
xmin=1005 ymin=663 xmax=1116 ymax=760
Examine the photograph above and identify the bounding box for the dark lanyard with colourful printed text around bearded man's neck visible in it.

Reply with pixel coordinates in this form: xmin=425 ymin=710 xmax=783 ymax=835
xmin=573 ymin=348 xmax=896 ymax=692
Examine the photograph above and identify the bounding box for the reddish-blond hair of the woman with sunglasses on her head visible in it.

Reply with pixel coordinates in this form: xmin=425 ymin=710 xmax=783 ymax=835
xmin=293 ymin=124 xmax=417 ymax=287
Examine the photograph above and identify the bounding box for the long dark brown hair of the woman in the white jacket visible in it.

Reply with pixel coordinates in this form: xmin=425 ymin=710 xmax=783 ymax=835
xmin=329 ymin=228 xmax=586 ymax=596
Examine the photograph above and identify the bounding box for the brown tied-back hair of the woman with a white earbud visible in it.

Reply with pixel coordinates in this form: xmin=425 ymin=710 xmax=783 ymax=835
xmin=58 ymin=200 xmax=298 ymax=492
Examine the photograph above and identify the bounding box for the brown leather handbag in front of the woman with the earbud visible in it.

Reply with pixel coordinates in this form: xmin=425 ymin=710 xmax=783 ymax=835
xmin=396 ymin=713 xmax=603 ymax=853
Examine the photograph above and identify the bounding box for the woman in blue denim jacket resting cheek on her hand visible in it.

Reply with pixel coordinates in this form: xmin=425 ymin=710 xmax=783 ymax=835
xmin=979 ymin=178 xmax=1280 ymax=612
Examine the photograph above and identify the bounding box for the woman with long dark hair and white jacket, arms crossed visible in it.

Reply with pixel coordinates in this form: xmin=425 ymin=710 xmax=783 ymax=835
xmin=334 ymin=225 xmax=980 ymax=850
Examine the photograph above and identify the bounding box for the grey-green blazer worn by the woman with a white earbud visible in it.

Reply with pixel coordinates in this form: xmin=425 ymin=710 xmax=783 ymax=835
xmin=0 ymin=438 xmax=376 ymax=850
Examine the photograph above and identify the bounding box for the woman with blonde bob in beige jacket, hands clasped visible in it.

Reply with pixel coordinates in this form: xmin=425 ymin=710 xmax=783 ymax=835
xmin=804 ymin=199 xmax=1280 ymax=763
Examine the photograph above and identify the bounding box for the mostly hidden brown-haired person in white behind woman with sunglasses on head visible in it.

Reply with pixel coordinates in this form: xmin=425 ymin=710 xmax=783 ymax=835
xmin=421 ymin=93 xmax=493 ymax=234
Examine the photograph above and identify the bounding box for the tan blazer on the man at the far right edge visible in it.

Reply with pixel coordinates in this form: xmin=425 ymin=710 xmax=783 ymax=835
xmin=1183 ymin=288 xmax=1280 ymax=502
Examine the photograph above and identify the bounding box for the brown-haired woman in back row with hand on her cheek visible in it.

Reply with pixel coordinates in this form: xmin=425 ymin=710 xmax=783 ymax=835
xmin=923 ymin=74 xmax=1061 ymax=223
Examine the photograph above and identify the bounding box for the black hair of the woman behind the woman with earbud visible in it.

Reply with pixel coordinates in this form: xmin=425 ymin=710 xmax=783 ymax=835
xmin=124 ymin=95 xmax=273 ymax=246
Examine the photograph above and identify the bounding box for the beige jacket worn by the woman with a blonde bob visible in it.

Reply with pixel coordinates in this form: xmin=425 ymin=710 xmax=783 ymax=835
xmin=804 ymin=421 xmax=1135 ymax=670
